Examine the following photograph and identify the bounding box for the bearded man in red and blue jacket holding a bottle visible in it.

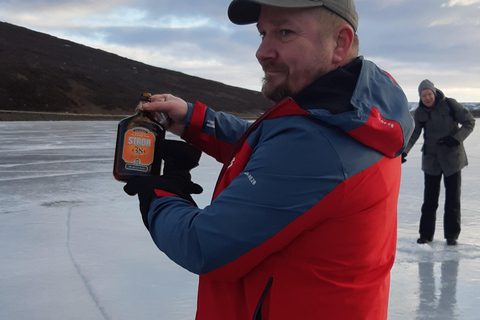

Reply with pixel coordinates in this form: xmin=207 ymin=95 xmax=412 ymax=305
xmin=125 ymin=0 xmax=413 ymax=320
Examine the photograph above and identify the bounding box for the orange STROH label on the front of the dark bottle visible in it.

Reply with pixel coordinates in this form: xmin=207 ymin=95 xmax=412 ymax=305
xmin=122 ymin=127 xmax=155 ymax=171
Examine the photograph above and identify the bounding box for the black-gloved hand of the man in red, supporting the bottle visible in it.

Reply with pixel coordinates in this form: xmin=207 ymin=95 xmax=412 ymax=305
xmin=123 ymin=140 xmax=203 ymax=230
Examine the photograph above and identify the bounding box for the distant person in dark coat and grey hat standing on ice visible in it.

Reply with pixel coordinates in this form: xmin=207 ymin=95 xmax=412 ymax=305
xmin=402 ymin=80 xmax=475 ymax=245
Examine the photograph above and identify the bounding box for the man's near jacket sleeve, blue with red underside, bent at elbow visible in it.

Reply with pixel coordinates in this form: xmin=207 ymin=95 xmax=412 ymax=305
xmin=144 ymin=116 xmax=383 ymax=280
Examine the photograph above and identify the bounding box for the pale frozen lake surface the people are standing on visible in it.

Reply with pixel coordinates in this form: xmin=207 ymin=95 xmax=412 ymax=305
xmin=0 ymin=121 xmax=480 ymax=320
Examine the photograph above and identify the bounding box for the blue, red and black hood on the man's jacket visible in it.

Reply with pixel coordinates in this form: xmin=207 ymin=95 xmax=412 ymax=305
xmin=293 ymin=57 xmax=414 ymax=158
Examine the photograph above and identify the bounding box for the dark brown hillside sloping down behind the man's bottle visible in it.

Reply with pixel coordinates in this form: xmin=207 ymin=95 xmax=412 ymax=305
xmin=0 ymin=22 xmax=271 ymax=120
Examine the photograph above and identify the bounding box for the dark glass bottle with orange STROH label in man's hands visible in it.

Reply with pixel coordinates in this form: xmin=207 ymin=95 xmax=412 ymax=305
xmin=113 ymin=93 xmax=165 ymax=182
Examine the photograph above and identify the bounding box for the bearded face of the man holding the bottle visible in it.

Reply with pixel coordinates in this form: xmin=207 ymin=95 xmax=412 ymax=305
xmin=256 ymin=6 xmax=335 ymax=102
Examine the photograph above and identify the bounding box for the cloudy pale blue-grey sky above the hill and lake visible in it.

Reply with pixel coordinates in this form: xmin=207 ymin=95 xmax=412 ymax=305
xmin=0 ymin=0 xmax=480 ymax=102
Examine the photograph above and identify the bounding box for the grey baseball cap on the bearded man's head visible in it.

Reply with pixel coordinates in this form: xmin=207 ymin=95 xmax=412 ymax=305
xmin=228 ymin=0 xmax=358 ymax=32
